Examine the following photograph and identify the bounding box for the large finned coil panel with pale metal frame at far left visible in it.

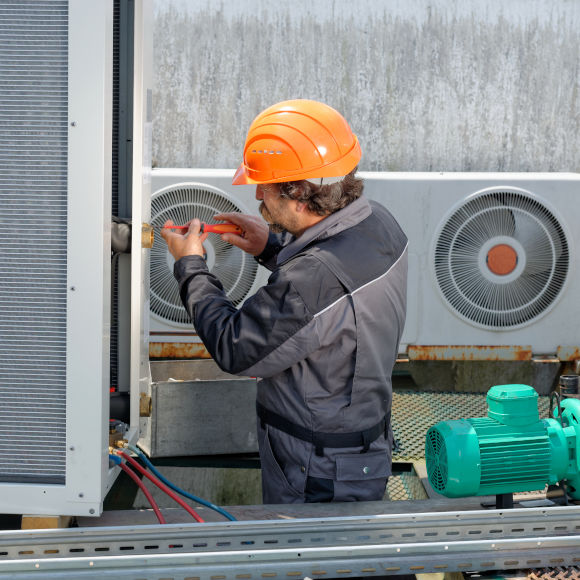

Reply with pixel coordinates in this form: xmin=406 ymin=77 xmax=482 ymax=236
xmin=0 ymin=0 xmax=152 ymax=515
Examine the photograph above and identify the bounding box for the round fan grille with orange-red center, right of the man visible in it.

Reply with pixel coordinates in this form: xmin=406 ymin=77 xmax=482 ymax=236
xmin=434 ymin=190 xmax=570 ymax=329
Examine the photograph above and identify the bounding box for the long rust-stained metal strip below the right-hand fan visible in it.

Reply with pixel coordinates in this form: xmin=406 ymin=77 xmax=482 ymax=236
xmin=407 ymin=345 xmax=532 ymax=361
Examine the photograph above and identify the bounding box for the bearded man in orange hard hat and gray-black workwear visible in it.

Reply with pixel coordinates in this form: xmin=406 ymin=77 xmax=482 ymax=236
xmin=162 ymin=100 xmax=407 ymax=503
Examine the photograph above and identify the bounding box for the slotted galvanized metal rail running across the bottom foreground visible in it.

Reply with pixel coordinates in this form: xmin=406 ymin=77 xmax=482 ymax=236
xmin=0 ymin=506 xmax=580 ymax=580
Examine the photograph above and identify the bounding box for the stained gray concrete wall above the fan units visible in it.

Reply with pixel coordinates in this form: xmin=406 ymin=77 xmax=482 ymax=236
xmin=154 ymin=0 xmax=580 ymax=171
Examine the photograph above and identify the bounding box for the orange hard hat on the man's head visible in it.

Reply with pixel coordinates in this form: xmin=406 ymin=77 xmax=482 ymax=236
xmin=232 ymin=99 xmax=361 ymax=185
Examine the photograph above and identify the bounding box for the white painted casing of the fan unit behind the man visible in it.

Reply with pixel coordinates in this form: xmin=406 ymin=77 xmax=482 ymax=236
xmin=152 ymin=169 xmax=580 ymax=359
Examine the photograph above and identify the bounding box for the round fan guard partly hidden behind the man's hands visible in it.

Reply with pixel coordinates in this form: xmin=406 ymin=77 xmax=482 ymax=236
xmin=150 ymin=183 xmax=258 ymax=327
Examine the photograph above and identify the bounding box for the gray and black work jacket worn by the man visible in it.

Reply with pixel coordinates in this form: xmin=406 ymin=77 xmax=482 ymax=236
xmin=175 ymin=196 xmax=407 ymax=500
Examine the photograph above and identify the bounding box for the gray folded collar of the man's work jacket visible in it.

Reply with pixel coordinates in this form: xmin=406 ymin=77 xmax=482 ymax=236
xmin=276 ymin=195 xmax=372 ymax=265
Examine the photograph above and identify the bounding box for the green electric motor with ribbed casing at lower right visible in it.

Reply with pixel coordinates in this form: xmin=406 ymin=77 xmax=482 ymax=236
xmin=425 ymin=385 xmax=580 ymax=499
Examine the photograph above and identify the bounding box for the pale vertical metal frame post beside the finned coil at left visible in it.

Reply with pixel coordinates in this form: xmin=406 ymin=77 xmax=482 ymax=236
xmin=66 ymin=0 xmax=113 ymax=515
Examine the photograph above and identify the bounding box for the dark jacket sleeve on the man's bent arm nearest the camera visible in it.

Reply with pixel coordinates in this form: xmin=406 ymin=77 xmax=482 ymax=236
xmin=174 ymin=256 xmax=317 ymax=377
